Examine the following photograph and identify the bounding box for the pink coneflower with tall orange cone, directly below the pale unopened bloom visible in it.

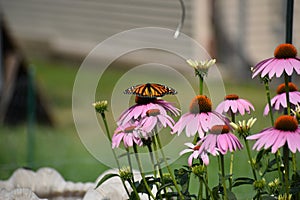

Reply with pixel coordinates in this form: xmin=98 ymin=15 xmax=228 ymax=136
xmin=172 ymin=95 xmax=226 ymax=138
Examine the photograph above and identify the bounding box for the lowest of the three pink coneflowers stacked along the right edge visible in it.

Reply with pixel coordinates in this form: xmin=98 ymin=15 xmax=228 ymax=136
xmin=247 ymin=115 xmax=300 ymax=153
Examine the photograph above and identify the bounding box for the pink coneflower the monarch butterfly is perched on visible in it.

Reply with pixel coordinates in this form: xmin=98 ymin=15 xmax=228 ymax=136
xmin=117 ymin=96 xmax=179 ymax=125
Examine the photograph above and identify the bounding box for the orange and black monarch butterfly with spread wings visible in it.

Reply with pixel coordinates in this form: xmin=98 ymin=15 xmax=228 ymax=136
xmin=124 ymin=83 xmax=177 ymax=98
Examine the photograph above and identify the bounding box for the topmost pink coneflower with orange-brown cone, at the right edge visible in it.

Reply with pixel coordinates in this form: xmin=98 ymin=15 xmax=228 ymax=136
xmin=252 ymin=44 xmax=300 ymax=79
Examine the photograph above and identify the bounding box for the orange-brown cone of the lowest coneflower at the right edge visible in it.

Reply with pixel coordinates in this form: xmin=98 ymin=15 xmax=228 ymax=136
xmin=275 ymin=115 xmax=298 ymax=132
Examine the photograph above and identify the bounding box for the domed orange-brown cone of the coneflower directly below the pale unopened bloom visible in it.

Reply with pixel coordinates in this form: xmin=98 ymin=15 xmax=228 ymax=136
xmin=190 ymin=95 xmax=212 ymax=114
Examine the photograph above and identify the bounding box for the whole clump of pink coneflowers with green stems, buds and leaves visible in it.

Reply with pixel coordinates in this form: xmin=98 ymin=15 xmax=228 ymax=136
xmin=93 ymin=44 xmax=300 ymax=200
